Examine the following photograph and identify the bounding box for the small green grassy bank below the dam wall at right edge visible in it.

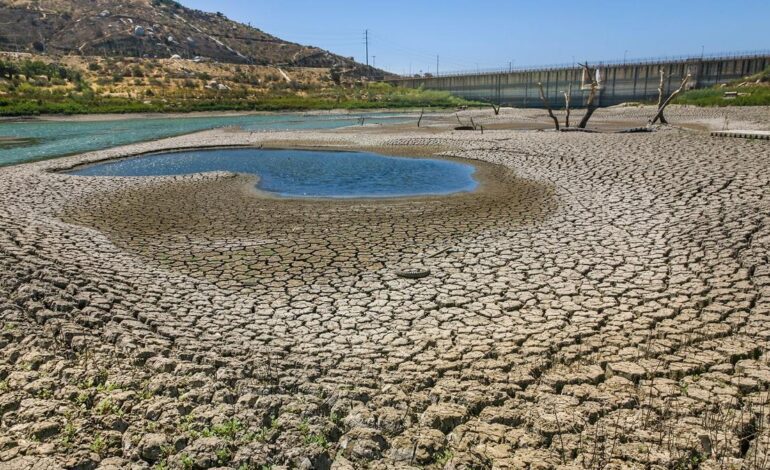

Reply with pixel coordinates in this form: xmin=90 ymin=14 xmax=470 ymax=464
xmin=675 ymin=67 xmax=770 ymax=106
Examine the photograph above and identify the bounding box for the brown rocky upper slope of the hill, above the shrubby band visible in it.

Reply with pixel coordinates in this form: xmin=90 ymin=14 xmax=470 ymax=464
xmin=0 ymin=0 xmax=364 ymax=70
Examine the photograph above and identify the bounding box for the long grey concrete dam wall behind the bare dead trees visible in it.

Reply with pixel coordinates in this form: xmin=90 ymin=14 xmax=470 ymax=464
xmin=392 ymin=51 xmax=770 ymax=107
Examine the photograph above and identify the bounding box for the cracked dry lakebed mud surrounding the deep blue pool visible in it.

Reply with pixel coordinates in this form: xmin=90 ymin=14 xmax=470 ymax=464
xmin=0 ymin=107 xmax=770 ymax=469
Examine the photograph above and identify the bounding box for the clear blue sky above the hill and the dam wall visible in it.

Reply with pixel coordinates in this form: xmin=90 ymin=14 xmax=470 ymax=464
xmin=181 ymin=0 xmax=770 ymax=73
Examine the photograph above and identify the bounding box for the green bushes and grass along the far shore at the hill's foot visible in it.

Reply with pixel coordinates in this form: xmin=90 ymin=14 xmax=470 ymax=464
xmin=0 ymin=61 xmax=474 ymax=116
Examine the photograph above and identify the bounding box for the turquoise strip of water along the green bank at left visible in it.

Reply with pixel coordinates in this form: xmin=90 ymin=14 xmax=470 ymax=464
xmin=0 ymin=113 xmax=404 ymax=166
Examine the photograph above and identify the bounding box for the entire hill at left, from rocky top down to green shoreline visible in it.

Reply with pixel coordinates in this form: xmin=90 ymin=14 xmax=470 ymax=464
xmin=0 ymin=0 xmax=465 ymax=116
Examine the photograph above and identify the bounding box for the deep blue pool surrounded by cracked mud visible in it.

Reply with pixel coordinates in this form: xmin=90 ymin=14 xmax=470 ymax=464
xmin=70 ymin=149 xmax=478 ymax=198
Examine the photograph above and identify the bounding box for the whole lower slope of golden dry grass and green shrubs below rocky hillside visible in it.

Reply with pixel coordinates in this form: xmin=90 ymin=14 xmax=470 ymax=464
xmin=0 ymin=56 xmax=467 ymax=116
